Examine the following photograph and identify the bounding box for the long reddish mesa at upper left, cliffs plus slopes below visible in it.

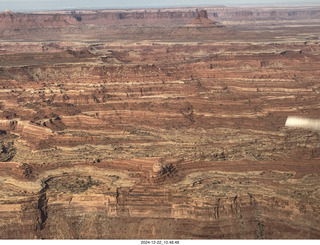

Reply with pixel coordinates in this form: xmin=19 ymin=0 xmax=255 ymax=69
xmin=0 ymin=9 xmax=225 ymax=40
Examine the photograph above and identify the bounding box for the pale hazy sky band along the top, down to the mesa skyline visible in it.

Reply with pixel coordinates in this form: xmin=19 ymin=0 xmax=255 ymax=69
xmin=0 ymin=0 xmax=320 ymax=12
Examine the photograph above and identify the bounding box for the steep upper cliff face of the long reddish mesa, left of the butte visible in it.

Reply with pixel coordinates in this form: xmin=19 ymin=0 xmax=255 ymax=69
xmin=0 ymin=10 xmax=197 ymax=29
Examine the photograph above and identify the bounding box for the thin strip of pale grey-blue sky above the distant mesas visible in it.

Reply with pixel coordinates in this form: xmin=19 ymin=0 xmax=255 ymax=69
xmin=0 ymin=0 xmax=320 ymax=12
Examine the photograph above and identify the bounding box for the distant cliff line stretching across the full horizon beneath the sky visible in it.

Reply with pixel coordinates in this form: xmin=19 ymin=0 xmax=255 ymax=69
xmin=0 ymin=6 xmax=320 ymax=29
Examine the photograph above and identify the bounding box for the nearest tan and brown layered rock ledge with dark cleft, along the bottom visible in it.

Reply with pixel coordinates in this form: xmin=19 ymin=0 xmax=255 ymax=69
xmin=0 ymin=159 xmax=320 ymax=239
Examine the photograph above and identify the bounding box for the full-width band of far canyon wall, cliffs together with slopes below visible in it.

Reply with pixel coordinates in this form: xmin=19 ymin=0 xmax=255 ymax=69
xmin=0 ymin=6 xmax=320 ymax=41
